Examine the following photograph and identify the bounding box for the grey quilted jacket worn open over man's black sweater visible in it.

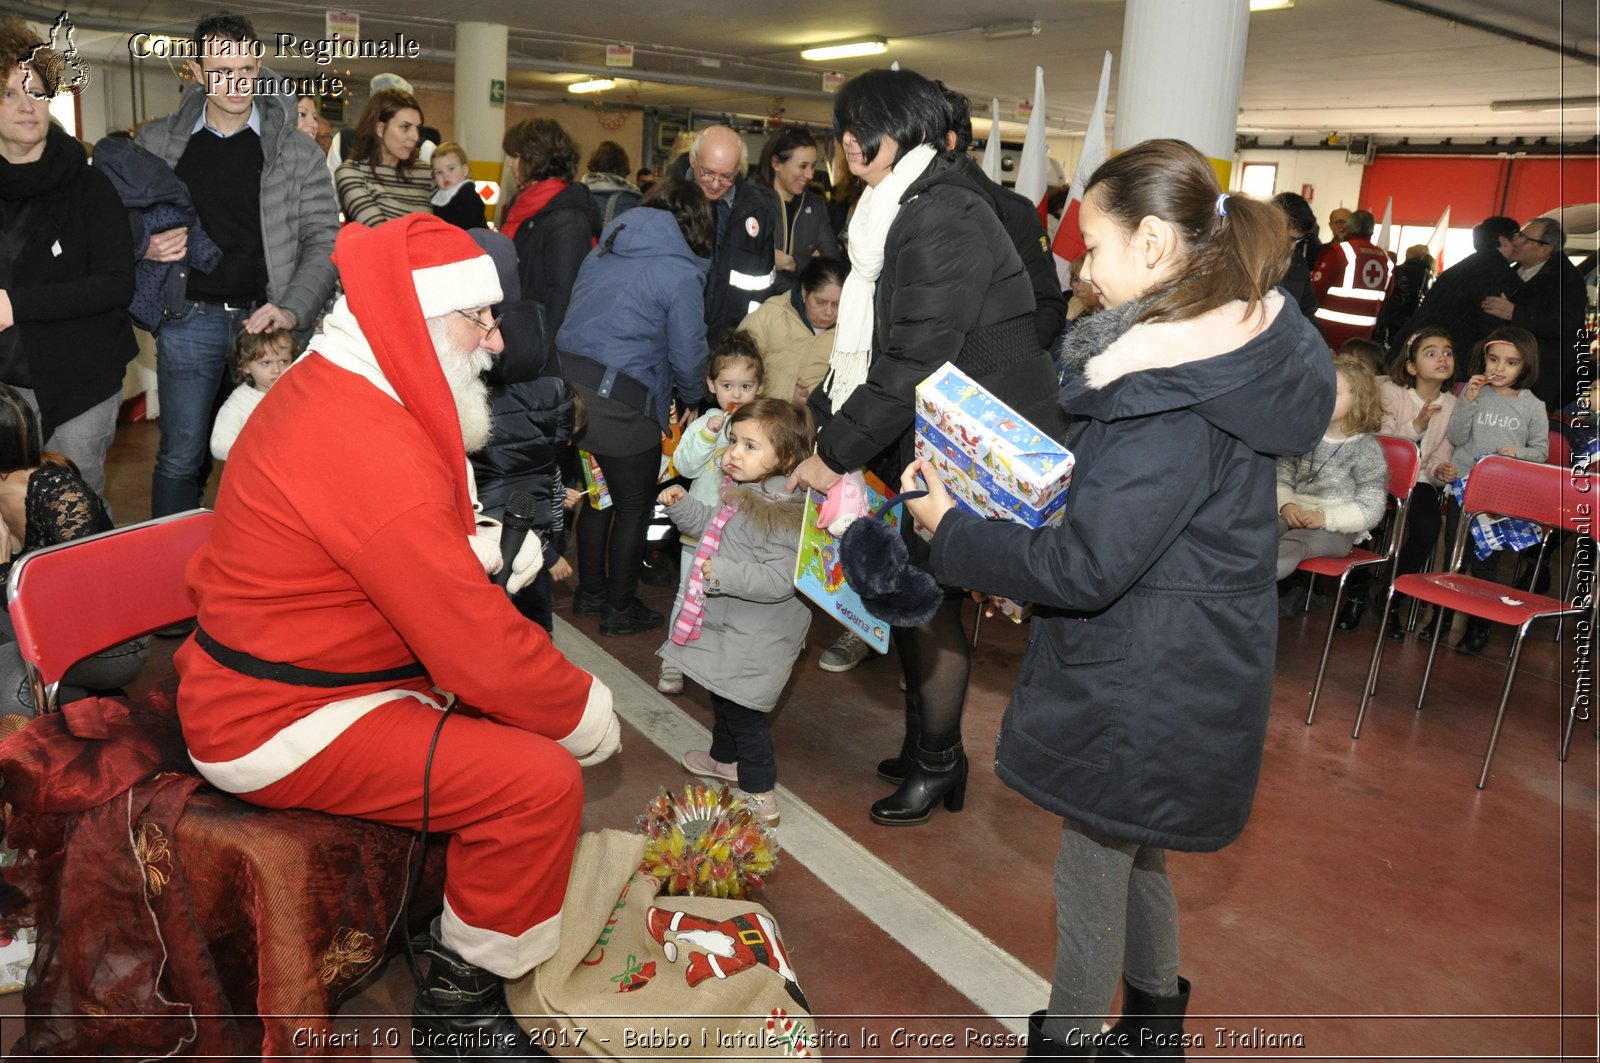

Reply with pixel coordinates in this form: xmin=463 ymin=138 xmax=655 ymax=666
xmin=139 ymin=76 xmax=339 ymax=344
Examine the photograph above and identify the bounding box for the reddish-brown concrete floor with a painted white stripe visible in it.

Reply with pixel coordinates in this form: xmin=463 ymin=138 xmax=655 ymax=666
xmin=0 ymin=424 xmax=1600 ymax=1060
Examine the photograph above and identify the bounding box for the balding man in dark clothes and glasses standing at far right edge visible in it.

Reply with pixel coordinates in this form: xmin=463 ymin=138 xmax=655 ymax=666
xmin=1483 ymin=218 xmax=1587 ymax=413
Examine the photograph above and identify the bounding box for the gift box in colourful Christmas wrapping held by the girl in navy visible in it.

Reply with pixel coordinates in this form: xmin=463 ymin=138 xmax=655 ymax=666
xmin=915 ymin=365 xmax=1074 ymax=623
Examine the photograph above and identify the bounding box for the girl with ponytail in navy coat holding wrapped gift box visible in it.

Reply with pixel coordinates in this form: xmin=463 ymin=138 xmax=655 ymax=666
xmin=902 ymin=141 xmax=1334 ymax=1058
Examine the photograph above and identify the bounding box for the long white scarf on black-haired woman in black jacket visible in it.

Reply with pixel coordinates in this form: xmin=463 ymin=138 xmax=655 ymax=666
xmin=822 ymin=144 xmax=934 ymax=410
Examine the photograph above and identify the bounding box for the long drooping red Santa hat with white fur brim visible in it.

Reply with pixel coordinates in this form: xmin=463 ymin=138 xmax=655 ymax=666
xmin=333 ymin=215 xmax=501 ymax=535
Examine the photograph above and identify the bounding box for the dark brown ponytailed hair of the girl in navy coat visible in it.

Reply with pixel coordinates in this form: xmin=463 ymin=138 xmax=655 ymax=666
xmin=1083 ymin=139 xmax=1290 ymax=322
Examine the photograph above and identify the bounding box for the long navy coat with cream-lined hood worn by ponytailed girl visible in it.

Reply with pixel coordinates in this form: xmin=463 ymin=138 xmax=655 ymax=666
xmin=933 ymin=291 xmax=1334 ymax=852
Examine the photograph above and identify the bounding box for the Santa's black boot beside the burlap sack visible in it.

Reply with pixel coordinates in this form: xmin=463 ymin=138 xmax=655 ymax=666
xmin=411 ymin=924 xmax=550 ymax=1060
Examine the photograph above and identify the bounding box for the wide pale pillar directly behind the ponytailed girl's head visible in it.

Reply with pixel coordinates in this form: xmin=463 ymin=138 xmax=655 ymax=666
xmin=1112 ymin=0 xmax=1250 ymax=189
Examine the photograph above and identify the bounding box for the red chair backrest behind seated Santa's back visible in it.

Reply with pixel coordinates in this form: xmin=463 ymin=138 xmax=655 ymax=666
xmin=6 ymin=509 xmax=211 ymax=712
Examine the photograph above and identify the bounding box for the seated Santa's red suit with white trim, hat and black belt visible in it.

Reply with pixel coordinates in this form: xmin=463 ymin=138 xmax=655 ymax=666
xmin=176 ymin=215 xmax=616 ymax=977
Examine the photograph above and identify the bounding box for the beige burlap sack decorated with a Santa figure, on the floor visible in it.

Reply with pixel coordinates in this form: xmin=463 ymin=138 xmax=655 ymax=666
xmin=506 ymin=831 xmax=821 ymax=1060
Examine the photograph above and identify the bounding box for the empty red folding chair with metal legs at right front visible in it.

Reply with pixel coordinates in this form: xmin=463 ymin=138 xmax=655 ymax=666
xmin=1350 ymin=455 xmax=1595 ymax=789
